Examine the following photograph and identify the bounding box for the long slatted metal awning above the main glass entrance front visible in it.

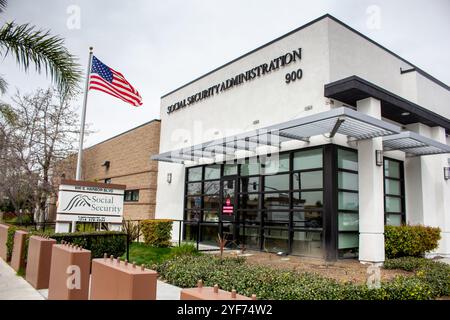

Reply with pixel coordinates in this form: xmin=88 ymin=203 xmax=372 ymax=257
xmin=152 ymin=107 xmax=401 ymax=163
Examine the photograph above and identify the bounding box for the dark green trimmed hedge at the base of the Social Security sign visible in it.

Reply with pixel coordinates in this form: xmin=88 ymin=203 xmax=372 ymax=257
xmin=50 ymin=231 xmax=127 ymax=258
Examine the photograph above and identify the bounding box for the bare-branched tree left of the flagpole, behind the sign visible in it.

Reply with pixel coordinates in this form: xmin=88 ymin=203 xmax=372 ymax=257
xmin=0 ymin=89 xmax=79 ymax=222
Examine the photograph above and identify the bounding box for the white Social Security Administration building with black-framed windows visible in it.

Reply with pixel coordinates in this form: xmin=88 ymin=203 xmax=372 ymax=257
xmin=154 ymin=15 xmax=450 ymax=262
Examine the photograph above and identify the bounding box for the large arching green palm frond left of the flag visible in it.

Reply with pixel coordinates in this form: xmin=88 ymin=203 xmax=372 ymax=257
xmin=0 ymin=22 xmax=81 ymax=93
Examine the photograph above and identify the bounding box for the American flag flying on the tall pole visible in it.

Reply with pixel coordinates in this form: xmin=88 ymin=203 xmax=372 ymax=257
xmin=89 ymin=56 xmax=142 ymax=107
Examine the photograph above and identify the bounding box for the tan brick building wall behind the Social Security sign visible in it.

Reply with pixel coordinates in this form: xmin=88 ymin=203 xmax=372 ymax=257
xmin=51 ymin=120 xmax=160 ymax=220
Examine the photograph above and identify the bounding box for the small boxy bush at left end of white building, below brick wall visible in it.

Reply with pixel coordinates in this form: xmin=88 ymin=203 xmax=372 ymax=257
xmin=141 ymin=219 xmax=173 ymax=248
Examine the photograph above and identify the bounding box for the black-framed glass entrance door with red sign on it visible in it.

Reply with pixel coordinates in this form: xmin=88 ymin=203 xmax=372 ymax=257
xmin=220 ymin=177 xmax=238 ymax=247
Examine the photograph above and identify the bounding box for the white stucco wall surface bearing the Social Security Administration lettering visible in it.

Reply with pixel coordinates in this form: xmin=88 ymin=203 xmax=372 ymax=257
xmin=156 ymin=18 xmax=450 ymax=252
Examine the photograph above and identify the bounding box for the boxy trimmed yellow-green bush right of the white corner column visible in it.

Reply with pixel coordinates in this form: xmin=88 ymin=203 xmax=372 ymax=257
xmin=384 ymin=225 xmax=441 ymax=259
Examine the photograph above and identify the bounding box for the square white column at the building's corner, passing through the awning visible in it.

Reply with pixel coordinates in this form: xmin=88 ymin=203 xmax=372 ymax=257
xmin=356 ymin=98 xmax=384 ymax=263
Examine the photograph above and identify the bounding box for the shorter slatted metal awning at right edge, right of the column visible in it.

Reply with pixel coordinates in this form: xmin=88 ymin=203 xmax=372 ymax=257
xmin=383 ymin=131 xmax=450 ymax=156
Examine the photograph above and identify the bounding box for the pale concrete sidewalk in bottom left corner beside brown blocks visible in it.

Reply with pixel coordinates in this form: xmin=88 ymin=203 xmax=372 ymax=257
xmin=0 ymin=258 xmax=44 ymax=300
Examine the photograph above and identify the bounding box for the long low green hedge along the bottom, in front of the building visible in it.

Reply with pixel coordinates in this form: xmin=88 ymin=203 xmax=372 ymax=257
xmin=156 ymin=255 xmax=444 ymax=300
